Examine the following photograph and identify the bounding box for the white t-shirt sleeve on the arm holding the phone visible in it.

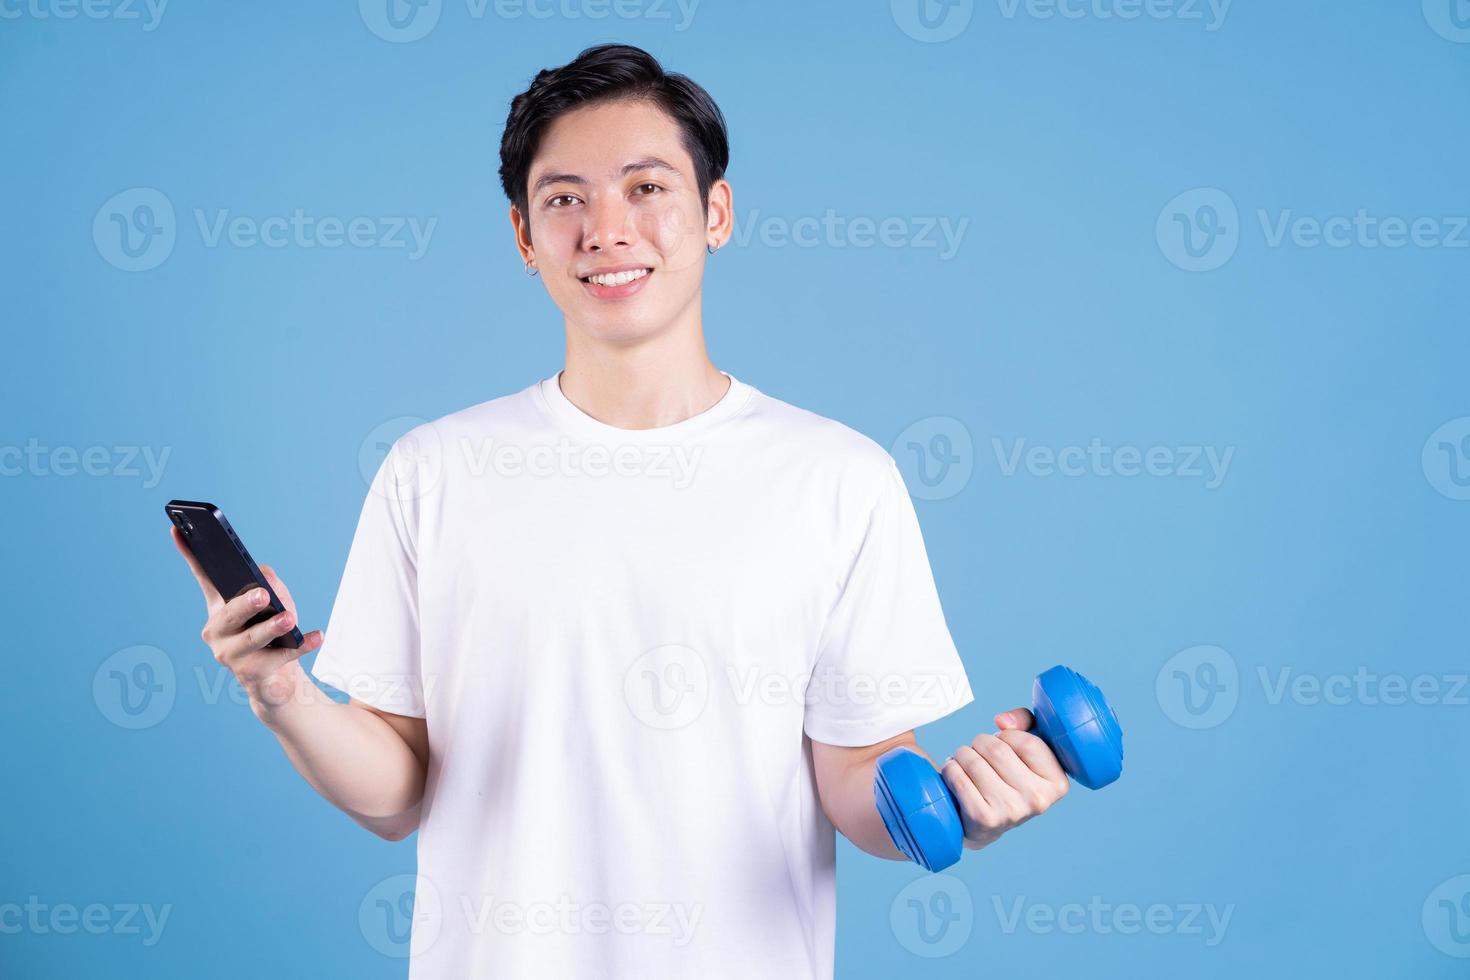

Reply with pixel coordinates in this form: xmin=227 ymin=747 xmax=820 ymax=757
xmin=312 ymin=451 xmax=425 ymax=718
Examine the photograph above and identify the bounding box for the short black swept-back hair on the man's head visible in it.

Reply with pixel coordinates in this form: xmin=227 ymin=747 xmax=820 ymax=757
xmin=500 ymin=44 xmax=731 ymax=227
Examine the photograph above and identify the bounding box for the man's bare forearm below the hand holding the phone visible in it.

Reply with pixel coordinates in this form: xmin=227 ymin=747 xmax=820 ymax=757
xmin=253 ymin=671 xmax=425 ymax=840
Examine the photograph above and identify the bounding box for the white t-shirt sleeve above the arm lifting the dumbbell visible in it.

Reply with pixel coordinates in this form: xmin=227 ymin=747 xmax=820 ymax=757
xmin=803 ymin=457 xmax=975 ymax=746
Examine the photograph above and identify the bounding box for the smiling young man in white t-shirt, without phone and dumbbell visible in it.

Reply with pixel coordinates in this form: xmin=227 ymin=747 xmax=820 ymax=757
xmin=175 ymin=46 xmax=1067 ymax=980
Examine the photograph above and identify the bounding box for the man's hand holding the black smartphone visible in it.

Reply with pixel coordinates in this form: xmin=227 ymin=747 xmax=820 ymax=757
xmin=169 ymin=526 xmax=322 ymax=721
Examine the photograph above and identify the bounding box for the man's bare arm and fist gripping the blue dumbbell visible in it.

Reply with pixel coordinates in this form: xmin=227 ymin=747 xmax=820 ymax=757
xmin=811 ymin=708 xmax=1069 ymax=861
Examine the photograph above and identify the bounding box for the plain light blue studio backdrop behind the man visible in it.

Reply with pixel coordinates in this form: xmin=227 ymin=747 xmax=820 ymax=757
xmin=0 ymin=0 xmax=1470 ymax=979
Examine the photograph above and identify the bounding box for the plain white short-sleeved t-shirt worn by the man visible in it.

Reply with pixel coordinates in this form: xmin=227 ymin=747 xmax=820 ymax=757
xmin=312 ymin=376 xmax=973 ymax=980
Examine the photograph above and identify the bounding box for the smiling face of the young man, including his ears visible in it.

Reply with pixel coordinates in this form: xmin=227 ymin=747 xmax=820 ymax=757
xmin=512 ymin=101 xmax=731 ymax=342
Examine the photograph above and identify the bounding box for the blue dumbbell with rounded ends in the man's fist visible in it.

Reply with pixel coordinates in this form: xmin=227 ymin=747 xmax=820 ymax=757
xmin=873 ymin=664 xmax=1123 ymax=871
